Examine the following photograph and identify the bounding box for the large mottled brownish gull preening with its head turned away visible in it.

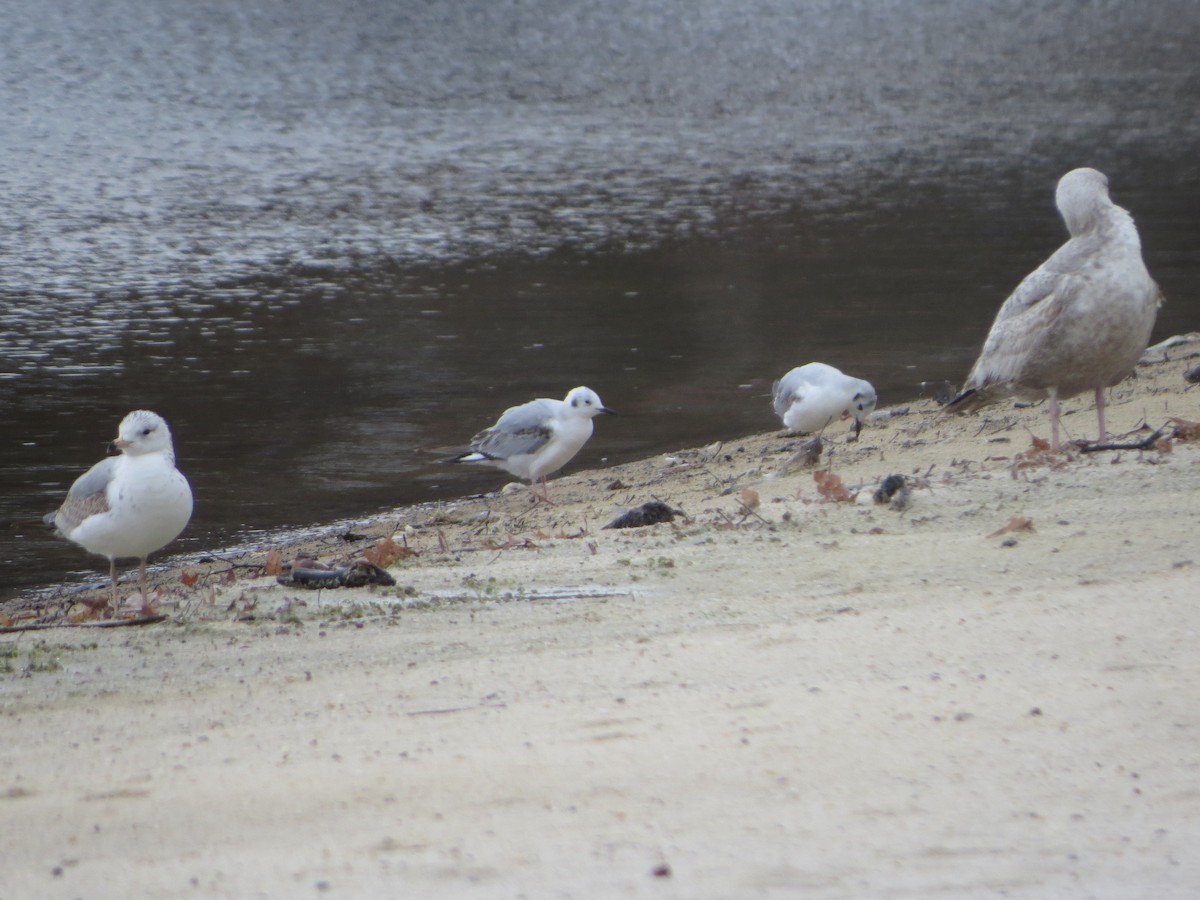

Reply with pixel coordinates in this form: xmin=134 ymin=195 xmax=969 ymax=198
xmin=946 ymin=168 xmax=1163 ymax=450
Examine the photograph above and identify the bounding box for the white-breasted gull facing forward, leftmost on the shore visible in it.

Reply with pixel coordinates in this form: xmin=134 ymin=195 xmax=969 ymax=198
xmin=44 ymin=409 xmax=192 ymax=614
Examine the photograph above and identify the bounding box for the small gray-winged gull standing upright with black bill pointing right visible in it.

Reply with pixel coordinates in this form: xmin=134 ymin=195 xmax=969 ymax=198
xmin=445 ymin=386 xmax=616 ymax=503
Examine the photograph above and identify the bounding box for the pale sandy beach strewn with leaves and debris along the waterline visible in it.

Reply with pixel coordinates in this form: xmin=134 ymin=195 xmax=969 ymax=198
xmin=0 ymin=342 xmax=1200 ymax=899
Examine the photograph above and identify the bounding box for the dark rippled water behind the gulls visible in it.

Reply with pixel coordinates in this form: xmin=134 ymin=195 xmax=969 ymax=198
xmin=0 ymin=0 xmax=1200 ymax=607
